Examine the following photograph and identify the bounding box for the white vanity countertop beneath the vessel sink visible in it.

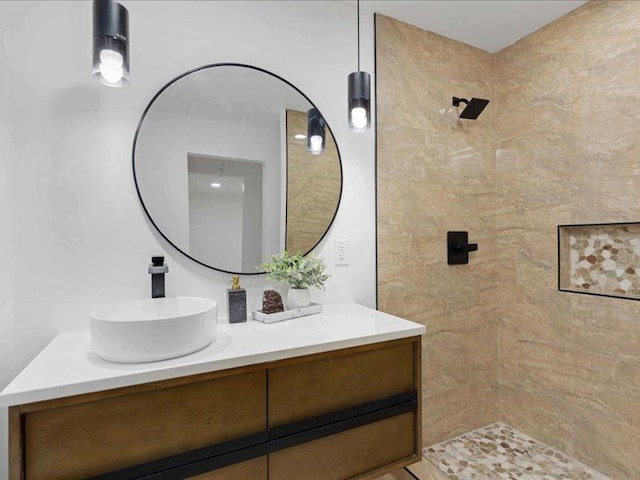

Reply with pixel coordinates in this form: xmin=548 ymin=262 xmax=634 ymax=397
xmin=0 ymin=303 xmax=426 ymax=406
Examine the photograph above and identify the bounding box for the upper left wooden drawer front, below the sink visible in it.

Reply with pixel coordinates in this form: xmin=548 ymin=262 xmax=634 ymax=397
xmin=24 ymin=371 xmax=266 ymax=480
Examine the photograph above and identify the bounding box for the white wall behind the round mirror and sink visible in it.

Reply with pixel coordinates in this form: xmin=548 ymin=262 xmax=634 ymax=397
xmin=0 ymin=0 xmax=375 ymax=472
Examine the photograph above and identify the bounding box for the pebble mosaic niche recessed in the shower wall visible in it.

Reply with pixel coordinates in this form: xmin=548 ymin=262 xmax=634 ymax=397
xmin=558 ymin=223 xmax=640 ymax=300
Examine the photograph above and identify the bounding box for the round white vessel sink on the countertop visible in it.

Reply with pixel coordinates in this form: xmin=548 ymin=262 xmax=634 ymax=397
xmin=91 ymin=297 xmax=218 ymax=363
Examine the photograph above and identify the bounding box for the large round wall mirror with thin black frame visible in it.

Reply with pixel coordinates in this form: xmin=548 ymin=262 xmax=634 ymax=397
xmin=133 ymin=63 xmax=342 ymax=274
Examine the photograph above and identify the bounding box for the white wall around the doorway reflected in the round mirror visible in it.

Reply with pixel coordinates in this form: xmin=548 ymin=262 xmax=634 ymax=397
xmin=136 ymin=109 xmax=281 ymax=264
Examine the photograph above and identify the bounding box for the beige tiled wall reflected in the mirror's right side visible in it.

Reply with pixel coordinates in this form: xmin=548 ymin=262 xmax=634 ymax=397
xmin=285 ymin=110 xmax=342 ymax=253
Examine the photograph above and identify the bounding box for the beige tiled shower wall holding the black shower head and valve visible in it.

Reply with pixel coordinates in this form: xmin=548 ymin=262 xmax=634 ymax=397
xmin=376 ymin=15 xmax=498 ymax=445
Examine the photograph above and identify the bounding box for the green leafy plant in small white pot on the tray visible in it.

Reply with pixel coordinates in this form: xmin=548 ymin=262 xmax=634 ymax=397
xmin=257 ymin=250 xmax=330 ymax=310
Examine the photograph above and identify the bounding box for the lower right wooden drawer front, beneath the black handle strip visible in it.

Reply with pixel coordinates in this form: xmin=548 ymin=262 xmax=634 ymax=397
xmin=269 ymin=412 xmax=416 ymax=480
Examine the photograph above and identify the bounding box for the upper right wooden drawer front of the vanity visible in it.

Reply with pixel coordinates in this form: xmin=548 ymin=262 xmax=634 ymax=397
xmin=269 ymin=341 xmax=416 ymax=428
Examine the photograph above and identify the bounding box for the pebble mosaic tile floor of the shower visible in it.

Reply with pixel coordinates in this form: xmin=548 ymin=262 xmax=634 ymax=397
xmin=423 ymin=423 xmax=610 ymax=480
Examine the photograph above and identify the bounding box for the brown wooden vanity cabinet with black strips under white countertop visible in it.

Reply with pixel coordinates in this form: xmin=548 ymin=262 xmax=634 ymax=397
xmin=10 ymin=337 xmax=421 ymax=480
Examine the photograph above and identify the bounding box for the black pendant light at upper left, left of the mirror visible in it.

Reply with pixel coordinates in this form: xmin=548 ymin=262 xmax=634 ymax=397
xmin=92 ymin=0 xmax=130 ymax=87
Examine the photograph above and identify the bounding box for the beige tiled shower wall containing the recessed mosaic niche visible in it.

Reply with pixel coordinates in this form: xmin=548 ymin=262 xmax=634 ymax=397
xmin=495 ymin=1 xmax=640 ymax=480
